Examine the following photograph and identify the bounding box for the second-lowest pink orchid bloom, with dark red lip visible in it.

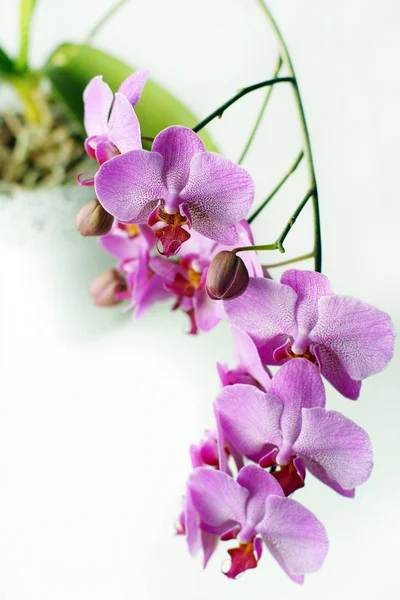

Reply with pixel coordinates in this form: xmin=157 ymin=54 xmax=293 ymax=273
xmin=215 ymin=358 xmax=373 ymax=497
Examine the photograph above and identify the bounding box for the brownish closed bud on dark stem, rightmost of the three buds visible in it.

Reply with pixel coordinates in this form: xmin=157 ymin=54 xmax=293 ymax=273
xmin=206 ymin=250 xmax=249 ymax=300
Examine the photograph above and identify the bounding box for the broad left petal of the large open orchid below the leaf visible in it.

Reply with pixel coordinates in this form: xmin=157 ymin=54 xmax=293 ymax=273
xmin=95 ymin=150 xmax=162 ymax=223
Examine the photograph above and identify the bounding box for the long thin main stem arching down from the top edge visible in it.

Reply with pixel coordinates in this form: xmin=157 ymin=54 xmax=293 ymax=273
xmin=257 ymin=0 xmax=322 ymax=272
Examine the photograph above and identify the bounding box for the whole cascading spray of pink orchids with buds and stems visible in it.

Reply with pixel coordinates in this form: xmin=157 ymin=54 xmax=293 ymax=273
xmin=77 ymin=0 xmax=394 ymax=583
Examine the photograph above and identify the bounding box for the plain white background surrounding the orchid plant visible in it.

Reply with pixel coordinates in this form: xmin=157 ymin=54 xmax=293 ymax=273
xmin=0 ymin=0 xmax=400 ymax=600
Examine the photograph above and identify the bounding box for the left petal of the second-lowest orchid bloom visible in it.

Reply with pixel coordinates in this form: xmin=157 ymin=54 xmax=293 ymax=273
xmin=215 ymin=383 xmax=283 ymax=461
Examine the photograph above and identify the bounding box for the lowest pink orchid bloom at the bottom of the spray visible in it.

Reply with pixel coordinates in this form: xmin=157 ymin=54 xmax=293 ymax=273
xmin=186 ymin=464 xmax=328 ymax=583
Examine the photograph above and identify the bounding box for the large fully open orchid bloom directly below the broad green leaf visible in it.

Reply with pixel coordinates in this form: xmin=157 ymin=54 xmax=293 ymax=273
xmin=95 ymin=125 xmax=254 ymax=256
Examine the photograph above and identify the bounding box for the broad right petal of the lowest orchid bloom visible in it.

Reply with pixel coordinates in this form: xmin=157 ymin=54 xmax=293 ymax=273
xmin=257 ymin=496 xmax=328 ymax=582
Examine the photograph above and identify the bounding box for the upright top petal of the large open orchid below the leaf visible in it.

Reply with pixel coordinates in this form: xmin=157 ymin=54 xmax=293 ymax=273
xmin=152 ymin=125 xmax=205 ymax=194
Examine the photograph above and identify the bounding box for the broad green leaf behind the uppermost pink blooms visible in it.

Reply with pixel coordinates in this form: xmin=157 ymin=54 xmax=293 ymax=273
xmin=42 ymin=43 xmax=218 ymax=152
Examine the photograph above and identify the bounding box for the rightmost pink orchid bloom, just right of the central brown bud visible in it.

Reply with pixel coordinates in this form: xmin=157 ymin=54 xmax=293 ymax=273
xmin=224 ymin=269 xmax=395 ymax=400
